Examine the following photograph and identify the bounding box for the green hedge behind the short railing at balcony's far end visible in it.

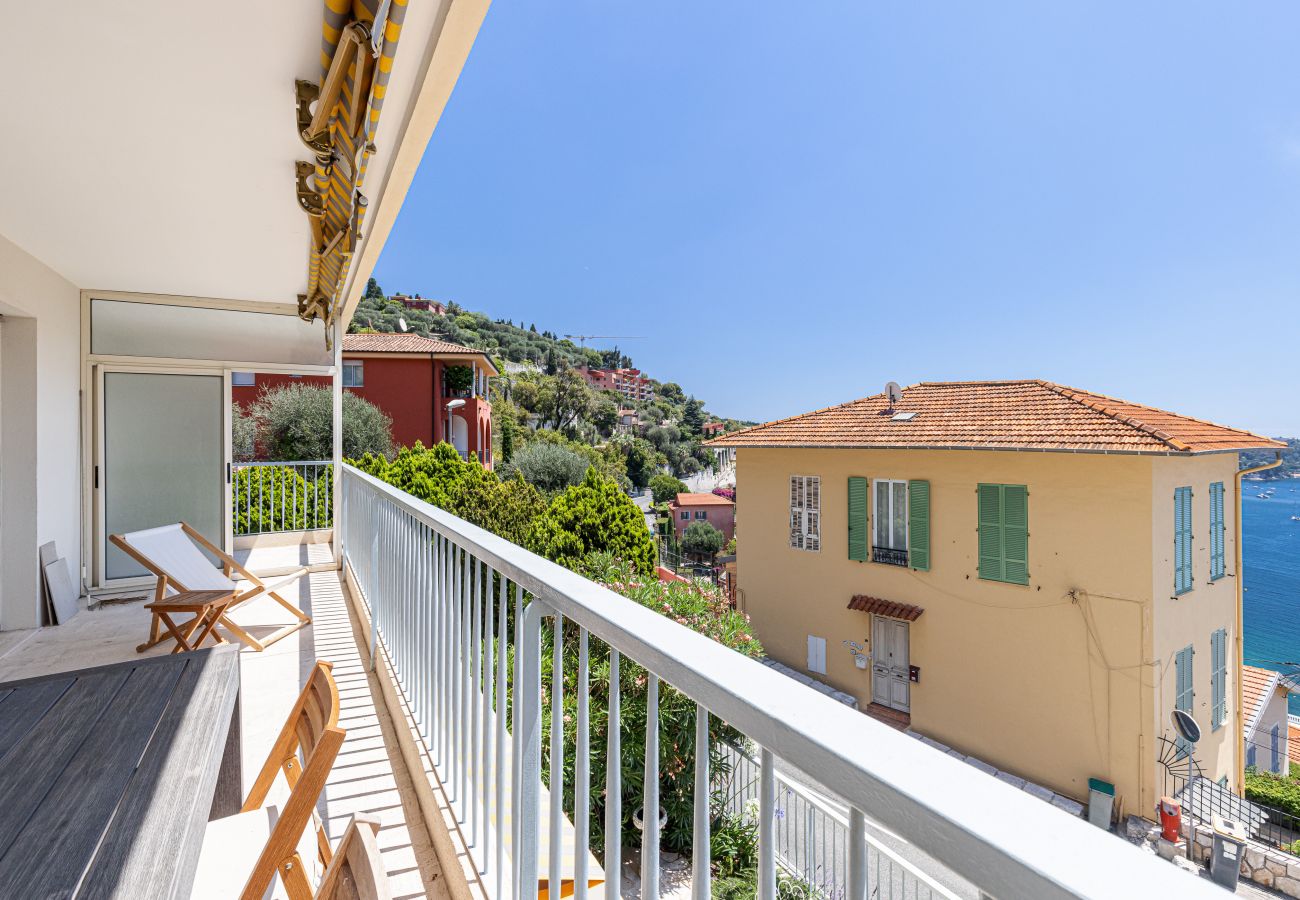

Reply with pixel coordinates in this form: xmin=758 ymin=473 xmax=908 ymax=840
xmin=234 ymin=466 xmax=334 ymax=535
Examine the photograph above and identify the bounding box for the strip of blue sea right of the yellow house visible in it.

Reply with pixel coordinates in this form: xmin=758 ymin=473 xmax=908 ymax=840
xmin=1229 ymin=479 xmax=1300 ymax=715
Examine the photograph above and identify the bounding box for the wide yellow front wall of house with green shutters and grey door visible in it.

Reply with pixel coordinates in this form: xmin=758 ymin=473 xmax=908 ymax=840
xmin=737 ymin=447 xmax=1235 ymax=814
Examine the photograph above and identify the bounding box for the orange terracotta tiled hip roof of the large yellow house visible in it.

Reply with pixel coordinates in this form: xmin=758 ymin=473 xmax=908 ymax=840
xmin=707 ymin=381 xmax=1284 ymax=454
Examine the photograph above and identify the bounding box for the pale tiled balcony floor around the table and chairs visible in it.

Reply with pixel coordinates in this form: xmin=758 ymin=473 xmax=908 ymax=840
xmin=0 ymin=572 xmax=445 ymax=899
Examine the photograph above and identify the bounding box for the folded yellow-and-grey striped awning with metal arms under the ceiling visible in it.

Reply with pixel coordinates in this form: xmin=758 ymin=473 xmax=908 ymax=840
xmin=298 ymin=0 xmax=407 ymax=343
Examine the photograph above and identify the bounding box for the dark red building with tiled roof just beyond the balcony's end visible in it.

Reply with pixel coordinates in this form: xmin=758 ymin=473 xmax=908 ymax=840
xmin=233 ymin=334 xmax=499 ymax=468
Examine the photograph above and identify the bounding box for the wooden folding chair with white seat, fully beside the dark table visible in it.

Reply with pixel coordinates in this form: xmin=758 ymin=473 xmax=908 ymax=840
xmin=194 ymin=662 xmax=345 ymax=900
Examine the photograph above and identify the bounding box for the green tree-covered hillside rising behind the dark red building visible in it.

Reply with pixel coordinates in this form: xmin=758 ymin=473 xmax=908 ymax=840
xmin=350 ymin=278 xmax=753 ymax=493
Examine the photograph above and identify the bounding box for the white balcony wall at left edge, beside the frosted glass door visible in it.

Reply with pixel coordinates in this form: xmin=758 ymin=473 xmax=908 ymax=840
xmin=0 ymin=235 xmax=81 ymax=631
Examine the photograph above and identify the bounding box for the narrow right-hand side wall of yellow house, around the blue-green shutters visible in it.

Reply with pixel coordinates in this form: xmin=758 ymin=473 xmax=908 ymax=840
xmin=1151 ymin=454 xmax=1242 ymax=782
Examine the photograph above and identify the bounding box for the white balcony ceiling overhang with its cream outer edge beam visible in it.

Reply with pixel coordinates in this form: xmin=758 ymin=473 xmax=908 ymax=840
xmin=0 ymin=0 xmax=488 ymax=330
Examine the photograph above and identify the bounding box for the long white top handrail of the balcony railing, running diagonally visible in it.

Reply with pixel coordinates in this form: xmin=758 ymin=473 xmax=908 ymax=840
xmin=343 ymin=463 xmax=1222 ymax=900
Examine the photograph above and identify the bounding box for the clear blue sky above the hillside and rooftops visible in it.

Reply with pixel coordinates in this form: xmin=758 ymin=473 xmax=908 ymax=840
xmin=376 ymin=0 xmax=1300 ymax=434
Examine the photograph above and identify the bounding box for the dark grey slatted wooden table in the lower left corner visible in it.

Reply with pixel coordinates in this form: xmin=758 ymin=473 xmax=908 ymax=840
xmin=0 ymin=646 xmax=242 ymax=900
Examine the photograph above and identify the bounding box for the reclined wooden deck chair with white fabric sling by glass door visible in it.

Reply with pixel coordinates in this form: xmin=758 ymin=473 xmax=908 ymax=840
xmin=108 ymin=522 xmax=312 ymax=653
